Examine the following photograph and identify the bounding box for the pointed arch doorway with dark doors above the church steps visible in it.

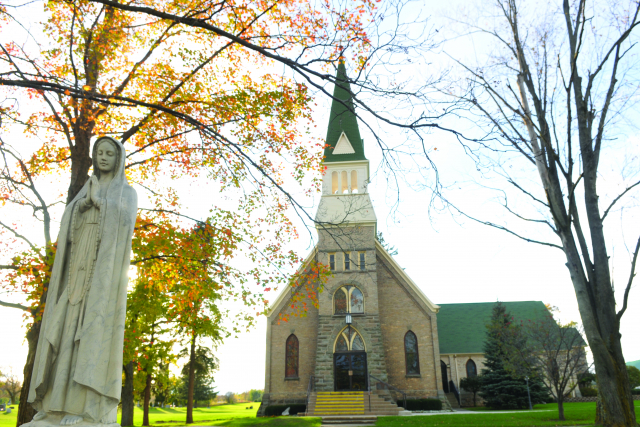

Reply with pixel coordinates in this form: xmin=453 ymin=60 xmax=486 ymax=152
xmin=333 ymin=326 xmax=369 ymax=391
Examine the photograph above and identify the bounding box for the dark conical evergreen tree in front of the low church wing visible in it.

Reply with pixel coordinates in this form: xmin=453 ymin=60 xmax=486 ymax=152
xmin=480 ymin=302 xmax=549 ymax=409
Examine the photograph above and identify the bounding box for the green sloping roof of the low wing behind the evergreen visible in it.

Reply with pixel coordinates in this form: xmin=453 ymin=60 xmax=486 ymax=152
xmin=437 ymin=301 xmax=549 ymax=354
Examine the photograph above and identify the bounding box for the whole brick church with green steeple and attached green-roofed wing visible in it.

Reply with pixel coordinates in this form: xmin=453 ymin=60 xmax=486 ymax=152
xmin=258 ymin=63 xmax=584 ymax=415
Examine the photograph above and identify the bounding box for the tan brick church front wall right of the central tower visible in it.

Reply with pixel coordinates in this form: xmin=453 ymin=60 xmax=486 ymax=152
xmin=378 ymin=258 xmax=441 ymax=398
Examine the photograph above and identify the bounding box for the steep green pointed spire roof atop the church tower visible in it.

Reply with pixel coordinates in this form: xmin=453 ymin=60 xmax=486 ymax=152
xmin=324 ymin=61 xmax=366 ymax=163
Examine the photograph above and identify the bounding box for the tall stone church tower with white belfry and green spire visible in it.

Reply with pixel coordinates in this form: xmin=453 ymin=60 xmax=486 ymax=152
xmin=314 ymin=62 xmax=387 ymax=392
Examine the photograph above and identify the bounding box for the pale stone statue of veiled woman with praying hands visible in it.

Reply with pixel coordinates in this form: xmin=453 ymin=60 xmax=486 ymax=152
xmin=28 ymin=137 xmax=138 ymax=427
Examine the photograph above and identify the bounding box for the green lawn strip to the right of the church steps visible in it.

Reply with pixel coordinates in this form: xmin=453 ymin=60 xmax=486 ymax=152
xmin=376 ymin=401 xmax=640 ymax=427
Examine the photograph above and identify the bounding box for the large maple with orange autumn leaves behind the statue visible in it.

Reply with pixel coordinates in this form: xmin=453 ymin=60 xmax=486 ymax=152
xmin=0 ymin=1 xmax=384 ymax=425
